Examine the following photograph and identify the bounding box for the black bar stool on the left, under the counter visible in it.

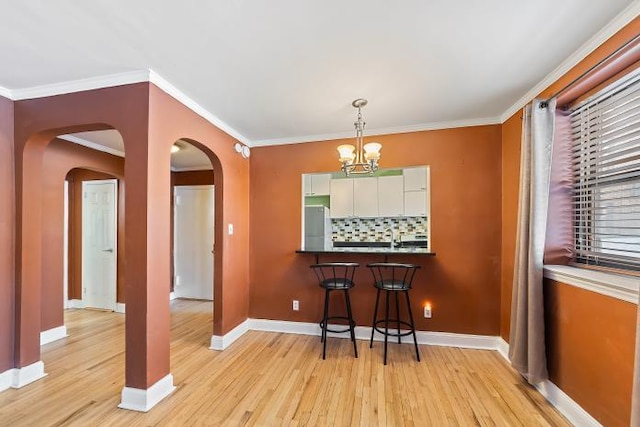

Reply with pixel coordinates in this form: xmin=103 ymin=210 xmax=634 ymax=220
xmin=311 ymin=262 xmax=359 ymax=360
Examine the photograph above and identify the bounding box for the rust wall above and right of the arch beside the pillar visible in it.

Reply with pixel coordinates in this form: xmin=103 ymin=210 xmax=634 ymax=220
xmin=149 ymin=85 xmax=249 ymax=336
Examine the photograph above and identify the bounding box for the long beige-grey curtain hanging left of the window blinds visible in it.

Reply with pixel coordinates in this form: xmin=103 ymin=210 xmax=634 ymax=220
xmin=509 ymin=100 xmax=556 ymax=384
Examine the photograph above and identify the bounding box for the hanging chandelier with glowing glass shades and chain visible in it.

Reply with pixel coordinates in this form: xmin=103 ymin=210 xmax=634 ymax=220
xmin=338 ymin=99 xmax=382 ymax=176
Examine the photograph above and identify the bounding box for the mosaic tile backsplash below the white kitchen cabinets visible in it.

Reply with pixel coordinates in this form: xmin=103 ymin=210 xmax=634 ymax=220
xmin=331 ymin=216 xmax=428 ymax=242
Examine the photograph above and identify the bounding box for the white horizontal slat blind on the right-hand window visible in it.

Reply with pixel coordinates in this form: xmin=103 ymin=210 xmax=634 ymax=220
xmin=570 ymin=75 xmax=640 ymax=271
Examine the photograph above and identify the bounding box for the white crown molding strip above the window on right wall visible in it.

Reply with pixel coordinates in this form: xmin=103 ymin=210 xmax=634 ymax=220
xmin=500 ymin=0 xmax=640 ymax=123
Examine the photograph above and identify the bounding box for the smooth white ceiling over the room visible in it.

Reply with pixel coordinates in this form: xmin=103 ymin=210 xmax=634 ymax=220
xmin=0 ymin=0 xmax=640 ymax=145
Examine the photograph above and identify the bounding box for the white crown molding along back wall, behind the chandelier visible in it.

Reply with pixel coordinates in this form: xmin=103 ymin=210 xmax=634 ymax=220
xmin=251 ymin=117 xmax=502 ymax=147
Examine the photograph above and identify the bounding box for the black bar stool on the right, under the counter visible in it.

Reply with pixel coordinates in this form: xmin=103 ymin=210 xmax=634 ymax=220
xmin=367 ymin=262 xmax=420 ymax=365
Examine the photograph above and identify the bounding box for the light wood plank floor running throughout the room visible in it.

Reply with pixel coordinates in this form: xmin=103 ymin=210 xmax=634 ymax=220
xmin=0 ymin=300 xmax=568 ymax=426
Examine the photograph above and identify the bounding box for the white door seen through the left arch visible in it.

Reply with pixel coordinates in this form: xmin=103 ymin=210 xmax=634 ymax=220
xmin=82 ymin=179 xmax=118 ymax=310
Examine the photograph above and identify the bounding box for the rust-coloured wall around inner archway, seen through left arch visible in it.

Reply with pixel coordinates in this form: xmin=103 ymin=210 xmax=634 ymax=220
xmin=40 ymin=139 xmax=124 ymax=331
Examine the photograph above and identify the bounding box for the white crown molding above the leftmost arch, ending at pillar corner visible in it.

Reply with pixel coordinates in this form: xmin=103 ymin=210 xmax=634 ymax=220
xmin=11 ymin=70 xmax=149 ymax=101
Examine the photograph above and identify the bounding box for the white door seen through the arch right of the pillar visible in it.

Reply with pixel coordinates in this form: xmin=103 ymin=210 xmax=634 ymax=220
xmin=173 ymin=185 xmax=214 ymax=300
